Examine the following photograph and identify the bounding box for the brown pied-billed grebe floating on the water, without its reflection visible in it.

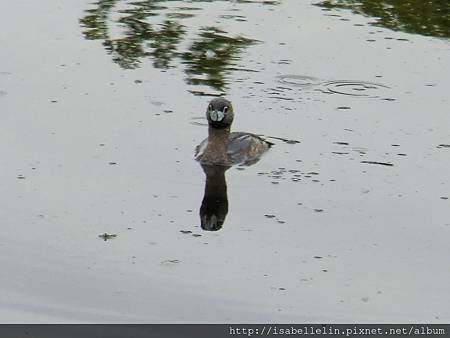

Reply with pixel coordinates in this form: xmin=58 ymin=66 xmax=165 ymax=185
xmin=195 ymin=98 xmax=272 ymax=167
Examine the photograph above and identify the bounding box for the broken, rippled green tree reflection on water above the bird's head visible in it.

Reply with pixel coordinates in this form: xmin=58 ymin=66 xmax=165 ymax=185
xmin=80 ymin=0 xmax=270 ymax=94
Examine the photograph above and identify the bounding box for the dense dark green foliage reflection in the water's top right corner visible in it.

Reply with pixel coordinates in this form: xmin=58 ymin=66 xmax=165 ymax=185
xmin=318 ymin=0 xmax=450 ymax=38
